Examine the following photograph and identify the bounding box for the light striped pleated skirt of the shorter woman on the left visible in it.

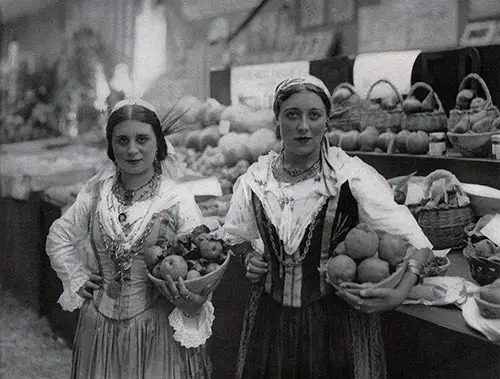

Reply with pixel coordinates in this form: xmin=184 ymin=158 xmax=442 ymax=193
xmin=71 ymin=300 xmax=211 ymax=379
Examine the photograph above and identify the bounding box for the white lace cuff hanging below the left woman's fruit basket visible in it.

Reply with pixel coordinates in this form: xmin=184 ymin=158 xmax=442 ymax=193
xmin=168 ymin=301 xmax=215 ymax=348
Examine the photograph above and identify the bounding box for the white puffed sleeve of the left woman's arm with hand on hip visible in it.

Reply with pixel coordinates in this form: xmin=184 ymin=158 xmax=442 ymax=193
xmin=46 ymin=184 xmax=95 ymax=312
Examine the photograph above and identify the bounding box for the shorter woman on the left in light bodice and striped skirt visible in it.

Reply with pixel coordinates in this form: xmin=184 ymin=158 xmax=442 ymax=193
xmin=46 ymin=100 xmax=214 ymax=379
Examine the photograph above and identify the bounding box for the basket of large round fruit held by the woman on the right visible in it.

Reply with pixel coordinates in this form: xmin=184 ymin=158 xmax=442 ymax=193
xmin=325 ymin=223 xmax=414 ymax=292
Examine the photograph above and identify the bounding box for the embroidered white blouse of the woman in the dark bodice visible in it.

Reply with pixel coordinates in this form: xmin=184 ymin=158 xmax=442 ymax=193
xmin=223 ymin=147 xmax=432 ymax=255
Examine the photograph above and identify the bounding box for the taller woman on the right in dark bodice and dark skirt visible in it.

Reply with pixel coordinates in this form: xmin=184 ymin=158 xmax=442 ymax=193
xmin=224 ymin=76 xmax=431 ymax=379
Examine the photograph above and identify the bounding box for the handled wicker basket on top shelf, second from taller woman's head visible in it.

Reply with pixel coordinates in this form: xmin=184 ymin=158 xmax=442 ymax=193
xmin=360 ymin=79 xmax=403 ymax=133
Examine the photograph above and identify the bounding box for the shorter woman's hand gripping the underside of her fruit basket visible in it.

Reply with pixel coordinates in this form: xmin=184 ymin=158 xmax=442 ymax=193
xmin=162 ymin=275 xmax=213 ymax=315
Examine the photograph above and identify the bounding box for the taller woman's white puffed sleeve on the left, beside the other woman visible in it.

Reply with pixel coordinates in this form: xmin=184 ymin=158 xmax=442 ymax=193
xmin=223 ymin=174 xmax=260 ymax=245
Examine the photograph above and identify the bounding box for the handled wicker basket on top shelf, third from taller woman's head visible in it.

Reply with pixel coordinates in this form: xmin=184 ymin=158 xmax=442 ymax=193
xmin=402 ymin=82 xmax=448 ymax=133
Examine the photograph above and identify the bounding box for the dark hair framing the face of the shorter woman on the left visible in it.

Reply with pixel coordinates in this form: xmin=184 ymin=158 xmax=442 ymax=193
xmin=106 ymin=104 xmax=167 ymax=162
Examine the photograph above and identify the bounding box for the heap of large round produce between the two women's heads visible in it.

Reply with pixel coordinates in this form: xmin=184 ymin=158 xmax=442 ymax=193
xmin=167 ymin=96 xmax=280 ymax=194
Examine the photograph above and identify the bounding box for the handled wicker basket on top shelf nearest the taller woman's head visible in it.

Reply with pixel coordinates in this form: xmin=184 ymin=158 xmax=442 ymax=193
xmin=328 ymin=82 xmax=362 ymax=132
